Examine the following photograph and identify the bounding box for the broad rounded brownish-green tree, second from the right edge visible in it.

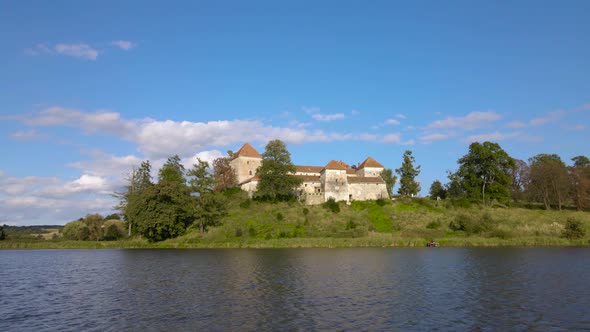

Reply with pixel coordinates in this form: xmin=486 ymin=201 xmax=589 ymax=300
xmin=529 ymin=154 xmax=569 ymax=210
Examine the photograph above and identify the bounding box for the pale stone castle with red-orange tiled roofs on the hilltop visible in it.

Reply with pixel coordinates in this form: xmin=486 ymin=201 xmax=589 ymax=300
xmin=230 ymin=143 xmax=389 ymax=205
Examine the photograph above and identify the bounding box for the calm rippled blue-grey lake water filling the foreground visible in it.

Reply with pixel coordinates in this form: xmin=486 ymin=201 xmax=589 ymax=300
xmin=0 ymin=248 xmax=590 ymax=332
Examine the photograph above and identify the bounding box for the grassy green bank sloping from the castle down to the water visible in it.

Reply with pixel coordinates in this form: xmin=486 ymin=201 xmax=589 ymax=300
xmin=0 ymin=196 xmax=590 ymax=249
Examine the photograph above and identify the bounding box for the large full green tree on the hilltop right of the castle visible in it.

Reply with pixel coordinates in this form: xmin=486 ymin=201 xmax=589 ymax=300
xmin=457 ymin=142 xmax=516 ymax=205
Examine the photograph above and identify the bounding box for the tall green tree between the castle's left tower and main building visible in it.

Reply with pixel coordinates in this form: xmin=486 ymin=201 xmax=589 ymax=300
xmin=256 ymin=139 xmax=302 ymax=200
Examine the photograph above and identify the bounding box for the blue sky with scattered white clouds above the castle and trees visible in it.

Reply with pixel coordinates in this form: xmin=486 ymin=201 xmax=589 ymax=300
xmin=0 ymin=1 xmax=590 ymax=225
